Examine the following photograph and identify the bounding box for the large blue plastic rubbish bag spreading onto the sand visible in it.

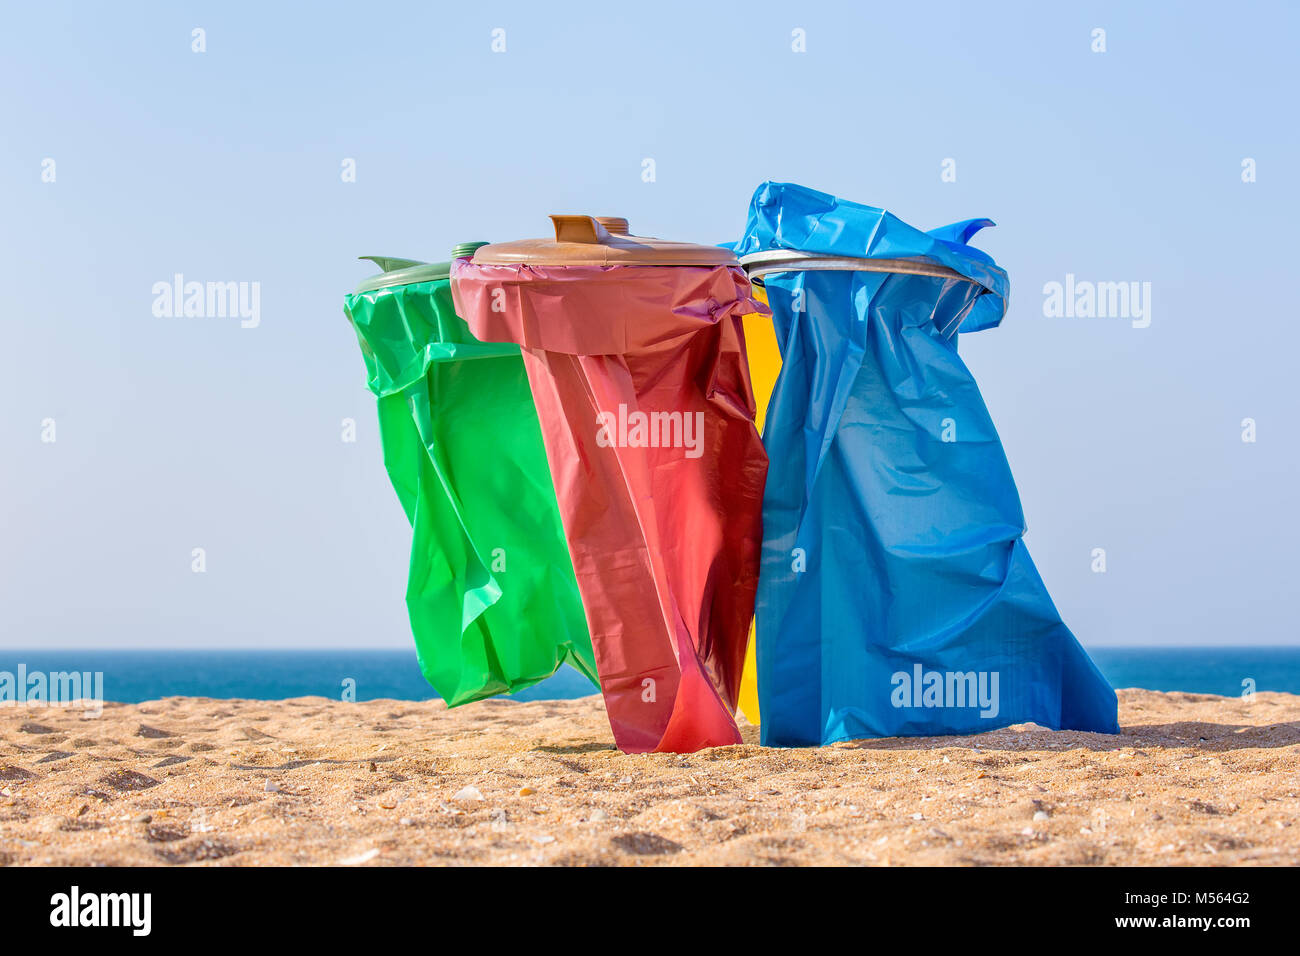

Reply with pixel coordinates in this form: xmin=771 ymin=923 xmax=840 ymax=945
xmin=736 ymin=183 xmax=1119 ymax=745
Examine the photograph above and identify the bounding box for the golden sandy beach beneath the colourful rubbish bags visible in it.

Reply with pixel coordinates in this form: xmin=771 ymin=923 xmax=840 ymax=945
xmin=0 ymin=691 xmax=1300 ymax=866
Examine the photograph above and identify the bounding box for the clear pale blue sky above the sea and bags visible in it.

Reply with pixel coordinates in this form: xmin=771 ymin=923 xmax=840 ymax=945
xmin=0 ymin=3 xmax=1300 ymax=648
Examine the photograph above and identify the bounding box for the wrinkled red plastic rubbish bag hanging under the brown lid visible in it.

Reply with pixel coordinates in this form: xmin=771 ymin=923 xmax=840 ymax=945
xmin=452 ymin=261 xmax=767 ymax=753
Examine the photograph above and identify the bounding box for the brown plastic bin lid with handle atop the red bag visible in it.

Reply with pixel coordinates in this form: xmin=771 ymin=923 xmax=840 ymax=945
xmin=475 ymin=216 xmax=737 ymax=265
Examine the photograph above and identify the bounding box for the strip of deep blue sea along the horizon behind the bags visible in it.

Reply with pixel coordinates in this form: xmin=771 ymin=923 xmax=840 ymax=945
xmin=0 ymin=648 xmax=1300 ymax=704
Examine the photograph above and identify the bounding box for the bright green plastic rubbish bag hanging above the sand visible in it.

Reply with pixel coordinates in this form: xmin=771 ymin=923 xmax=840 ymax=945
xmin=345 ymin=251 xmax=599 ymax=706
